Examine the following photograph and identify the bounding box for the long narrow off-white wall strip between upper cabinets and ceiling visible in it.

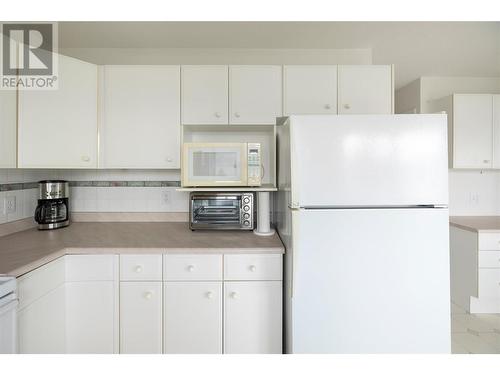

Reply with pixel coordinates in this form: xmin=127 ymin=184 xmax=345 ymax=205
xmin=59 ymin=48 xmax=372 ymax=65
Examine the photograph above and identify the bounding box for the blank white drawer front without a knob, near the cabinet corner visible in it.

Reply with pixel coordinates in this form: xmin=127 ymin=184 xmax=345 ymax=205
xmin=66 ymin=254 xmax=118 ymax=282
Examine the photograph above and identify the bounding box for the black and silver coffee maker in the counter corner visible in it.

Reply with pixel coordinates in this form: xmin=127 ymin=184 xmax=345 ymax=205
xmin=35 ymin=180 xmax=69 ymax=230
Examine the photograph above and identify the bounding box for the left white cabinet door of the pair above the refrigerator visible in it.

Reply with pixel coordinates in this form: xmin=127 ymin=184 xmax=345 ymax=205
xmin=283 ymin=65 xmax=337 ymax=116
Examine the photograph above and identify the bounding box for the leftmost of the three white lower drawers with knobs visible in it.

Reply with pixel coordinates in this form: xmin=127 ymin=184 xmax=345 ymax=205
xmin=120 ymin=254 xmax=163 ymax=281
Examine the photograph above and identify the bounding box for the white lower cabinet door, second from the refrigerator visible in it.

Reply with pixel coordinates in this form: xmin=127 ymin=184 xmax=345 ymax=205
xmin=163 ymin=281 xmax=222 ymax=354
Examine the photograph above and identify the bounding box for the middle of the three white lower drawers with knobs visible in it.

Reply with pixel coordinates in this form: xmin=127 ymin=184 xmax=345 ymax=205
xmin=163 ymin=254 xmax=222 ymax=281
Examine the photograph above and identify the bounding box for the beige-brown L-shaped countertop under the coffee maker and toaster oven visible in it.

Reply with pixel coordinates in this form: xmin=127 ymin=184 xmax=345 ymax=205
xmin=0 ymin=222 xmax=284 ymax=276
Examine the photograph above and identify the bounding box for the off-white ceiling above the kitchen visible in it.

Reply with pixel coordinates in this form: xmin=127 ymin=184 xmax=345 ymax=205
xmin=59 ymin=22 xmax=500 ymax=87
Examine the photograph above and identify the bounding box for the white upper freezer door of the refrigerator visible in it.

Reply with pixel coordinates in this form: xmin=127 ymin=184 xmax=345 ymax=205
xmin=290 ymin=114 xmax=448 ymax=207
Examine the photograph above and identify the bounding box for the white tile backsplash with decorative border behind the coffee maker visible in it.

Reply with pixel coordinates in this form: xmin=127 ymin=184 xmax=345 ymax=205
xmin=0 ymin=169 xmax=188 ymax=224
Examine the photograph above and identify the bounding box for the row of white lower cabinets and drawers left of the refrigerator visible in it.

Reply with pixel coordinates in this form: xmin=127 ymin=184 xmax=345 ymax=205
xmin=18 ymin=254 xmax=282 ymax=354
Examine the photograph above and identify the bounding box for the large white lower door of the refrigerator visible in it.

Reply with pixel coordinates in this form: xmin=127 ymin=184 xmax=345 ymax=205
xmin=286 ymin=208 xmax=451 ymax=353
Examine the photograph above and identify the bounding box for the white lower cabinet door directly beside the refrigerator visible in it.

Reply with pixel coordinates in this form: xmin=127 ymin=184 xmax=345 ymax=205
xmin=224 ymin=281 xmax=282 ymax=354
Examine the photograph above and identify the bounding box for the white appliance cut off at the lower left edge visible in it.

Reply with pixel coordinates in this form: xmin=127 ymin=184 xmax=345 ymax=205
xmin=0 ymin=275 xmax=18 ymax=354
